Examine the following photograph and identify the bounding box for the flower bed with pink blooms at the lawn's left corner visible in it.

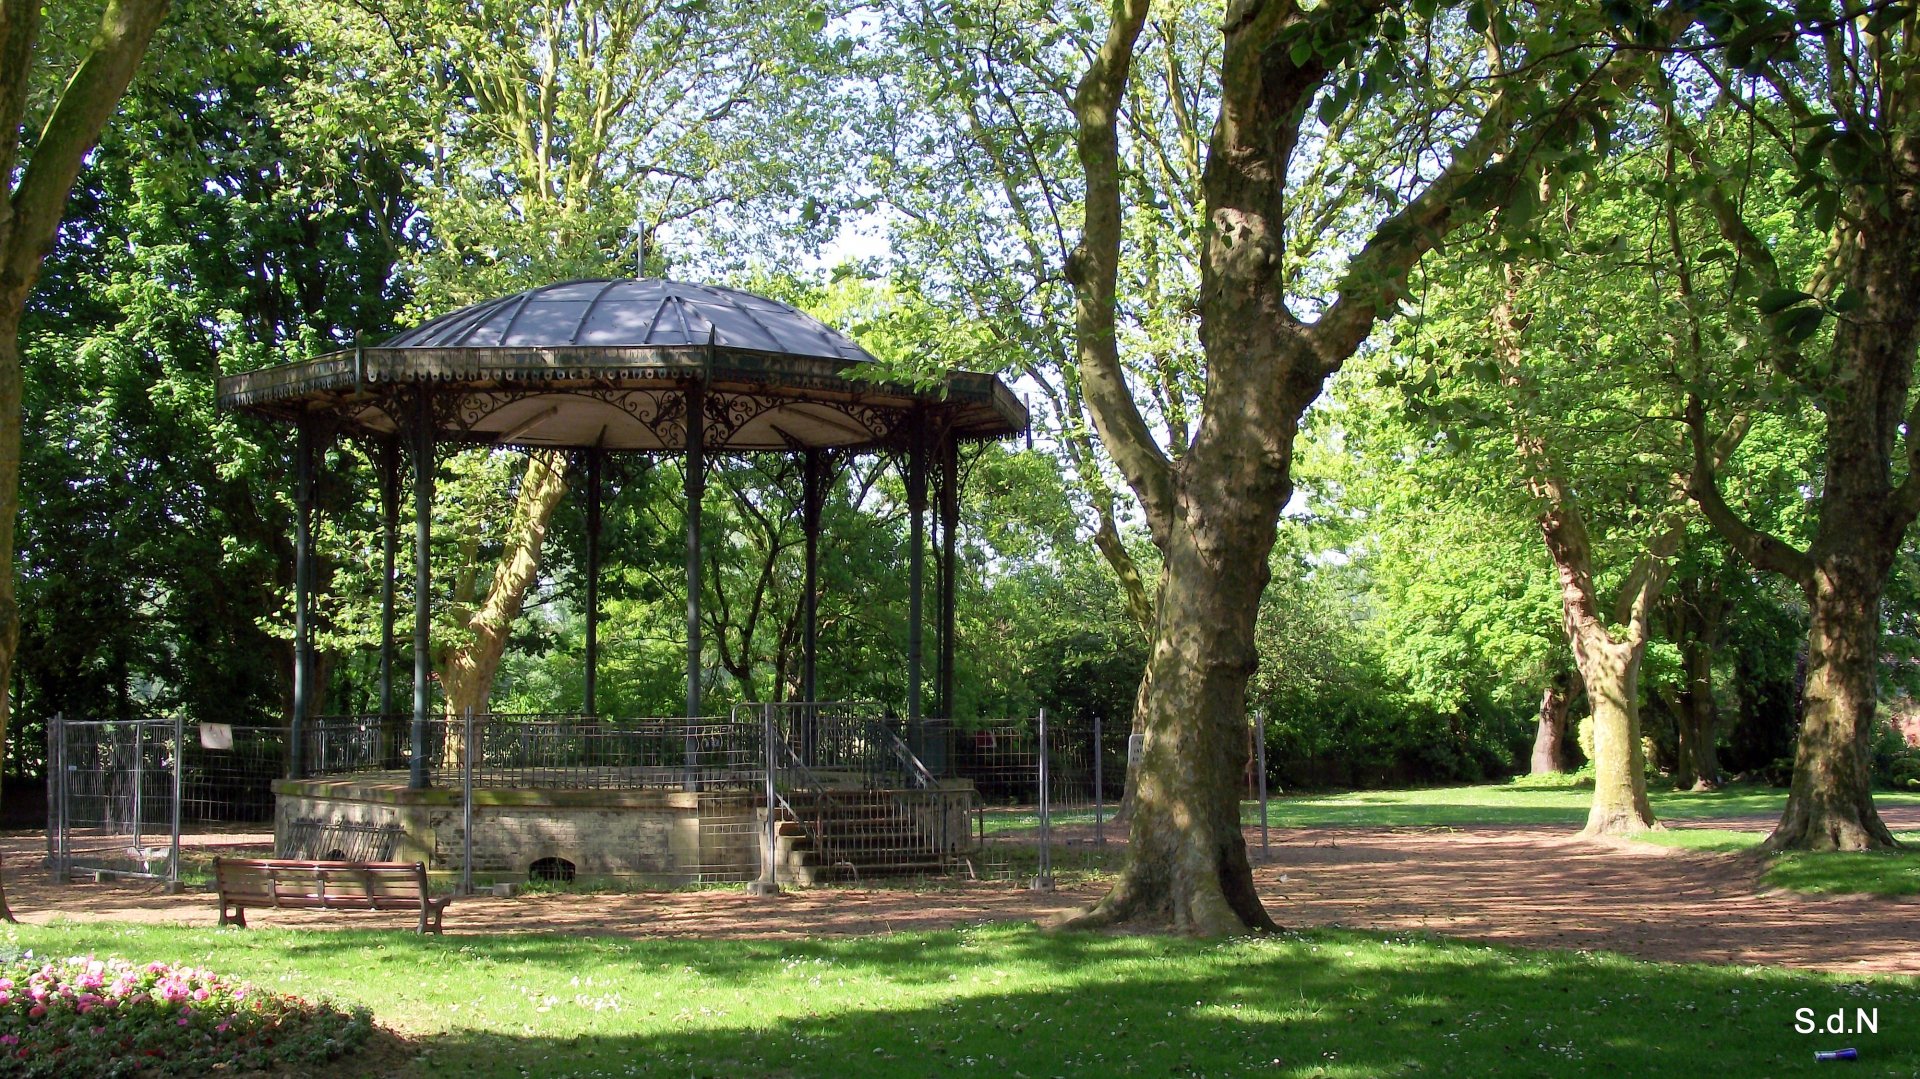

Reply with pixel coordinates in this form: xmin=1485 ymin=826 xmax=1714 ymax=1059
xmin=0 ymin=952 xmax=372 ymax=1075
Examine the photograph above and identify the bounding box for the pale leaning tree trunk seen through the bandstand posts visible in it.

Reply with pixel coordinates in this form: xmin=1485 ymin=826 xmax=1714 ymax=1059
xmin=440 ymin=449 xmax=566 ymax=766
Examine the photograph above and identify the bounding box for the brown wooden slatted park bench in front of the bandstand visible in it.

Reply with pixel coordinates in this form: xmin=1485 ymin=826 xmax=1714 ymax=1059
xmin=213 ymin=858 xmax=453 ymax=933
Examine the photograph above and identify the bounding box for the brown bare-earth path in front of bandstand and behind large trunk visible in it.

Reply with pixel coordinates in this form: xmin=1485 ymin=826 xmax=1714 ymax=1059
xmin=0 ymin=808 xmax=1920 ymax=975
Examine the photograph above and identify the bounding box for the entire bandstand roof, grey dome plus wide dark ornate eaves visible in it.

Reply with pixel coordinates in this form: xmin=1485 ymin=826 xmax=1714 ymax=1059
xmin=219 ymin=278 xmax=1027 ymax=453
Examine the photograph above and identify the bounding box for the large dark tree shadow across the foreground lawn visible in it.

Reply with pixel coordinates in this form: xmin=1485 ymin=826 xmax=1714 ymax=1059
xmin=378 ymin=931 xmax=1920 ymax=1077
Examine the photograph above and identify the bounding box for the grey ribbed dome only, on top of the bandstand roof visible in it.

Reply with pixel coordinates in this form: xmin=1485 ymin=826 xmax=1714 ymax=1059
xmin=382 ymin=278 xmax=874 ymax=363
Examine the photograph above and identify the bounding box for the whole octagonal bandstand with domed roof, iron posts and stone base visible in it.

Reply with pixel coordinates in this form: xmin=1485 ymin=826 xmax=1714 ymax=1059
xmin=219 ymin=278 xmax=1027 ymax=883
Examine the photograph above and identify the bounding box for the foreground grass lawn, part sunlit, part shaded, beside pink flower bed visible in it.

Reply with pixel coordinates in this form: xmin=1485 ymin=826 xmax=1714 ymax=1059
xmin=0 ymin=923 xmax=1920 ymax=1079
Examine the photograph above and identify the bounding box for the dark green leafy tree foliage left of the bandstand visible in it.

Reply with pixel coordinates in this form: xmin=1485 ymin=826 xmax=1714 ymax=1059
xmin=8 ymin=2 xmax=409 ymax=756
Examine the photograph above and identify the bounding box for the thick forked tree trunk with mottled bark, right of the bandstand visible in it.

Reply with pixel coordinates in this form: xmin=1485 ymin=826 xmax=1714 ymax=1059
xmin=1066 ymin=0 xmax=1536 ymax=933
